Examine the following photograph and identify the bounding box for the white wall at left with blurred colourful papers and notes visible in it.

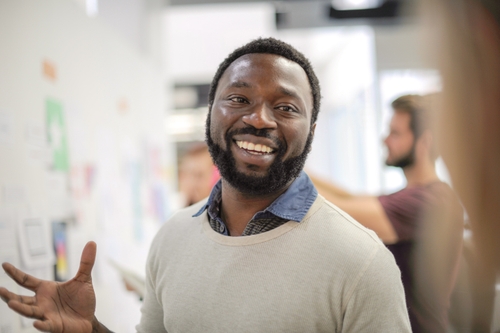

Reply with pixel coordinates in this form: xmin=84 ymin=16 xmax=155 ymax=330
xmin=0 ymin=0 xmax=174 ymax=333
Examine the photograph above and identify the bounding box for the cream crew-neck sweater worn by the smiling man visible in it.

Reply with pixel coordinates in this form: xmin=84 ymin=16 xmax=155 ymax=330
xmin=137 ymin=196 xmax=411 ymax=333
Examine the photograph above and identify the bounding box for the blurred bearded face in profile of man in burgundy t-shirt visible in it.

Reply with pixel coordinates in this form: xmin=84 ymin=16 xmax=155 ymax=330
xmin=384 ymin=111 xmax=415 ymax=168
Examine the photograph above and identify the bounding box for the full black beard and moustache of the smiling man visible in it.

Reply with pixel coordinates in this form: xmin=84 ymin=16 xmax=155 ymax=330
xmin=205 ymin=113 xmax=313 ymax=196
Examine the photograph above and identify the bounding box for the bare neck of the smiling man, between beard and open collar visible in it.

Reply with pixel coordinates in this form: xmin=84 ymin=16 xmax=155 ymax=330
xmin=221 ymin=179 xmax=290 ymax=236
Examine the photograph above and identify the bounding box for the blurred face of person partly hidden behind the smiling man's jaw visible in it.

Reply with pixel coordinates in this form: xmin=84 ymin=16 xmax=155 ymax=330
xmin=179 ymin=142 xmax=220 ymax=207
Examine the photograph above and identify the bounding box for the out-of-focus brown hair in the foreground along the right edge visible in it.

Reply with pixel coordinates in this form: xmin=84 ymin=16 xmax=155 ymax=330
xmin=422 ymin=0 xmax=500 ymax=332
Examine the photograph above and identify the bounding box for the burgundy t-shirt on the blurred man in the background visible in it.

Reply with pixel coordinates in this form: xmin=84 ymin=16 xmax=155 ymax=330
xmin=378 ymin=182 xmax=463 ymax=333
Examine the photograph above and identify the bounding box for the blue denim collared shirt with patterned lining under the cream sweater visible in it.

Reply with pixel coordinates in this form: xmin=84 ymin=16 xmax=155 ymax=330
xmin=193 ymin=171 xmax=318 ymax=236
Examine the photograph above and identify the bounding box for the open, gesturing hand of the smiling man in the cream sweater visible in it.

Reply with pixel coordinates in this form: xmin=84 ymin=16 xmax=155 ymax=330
xmin=0 ymin=242 xmax=110 ymax=333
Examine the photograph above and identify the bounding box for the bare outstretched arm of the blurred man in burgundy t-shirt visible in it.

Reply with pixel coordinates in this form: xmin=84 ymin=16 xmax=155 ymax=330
xmin=309 ymin=175 xmax=398 ymax=244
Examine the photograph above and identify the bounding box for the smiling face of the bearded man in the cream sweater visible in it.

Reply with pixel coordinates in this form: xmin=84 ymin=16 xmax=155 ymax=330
xmin=207 ymin=54 xmax=314 ymax=195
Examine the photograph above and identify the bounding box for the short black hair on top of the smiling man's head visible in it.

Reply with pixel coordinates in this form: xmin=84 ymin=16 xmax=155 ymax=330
xmin=208 ymin=37 xmax=321 ymax=125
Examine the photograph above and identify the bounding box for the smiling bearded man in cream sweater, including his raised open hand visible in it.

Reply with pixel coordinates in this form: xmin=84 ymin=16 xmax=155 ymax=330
xmin=0 ymin=38 xmax=410 ymax=333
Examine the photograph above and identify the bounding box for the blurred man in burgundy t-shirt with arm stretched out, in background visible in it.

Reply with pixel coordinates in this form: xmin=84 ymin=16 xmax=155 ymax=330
xmin=313 ymin=95 xmax=463 ymax=333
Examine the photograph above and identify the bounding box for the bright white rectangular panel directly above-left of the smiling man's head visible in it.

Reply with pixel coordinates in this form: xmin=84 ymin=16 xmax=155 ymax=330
xmin=164 ymin=3 xmax=274 ymax=83
